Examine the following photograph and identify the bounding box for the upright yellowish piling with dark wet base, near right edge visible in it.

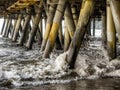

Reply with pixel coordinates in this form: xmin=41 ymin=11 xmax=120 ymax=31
xmin=107 ymin=0 xmax=116 ymax=60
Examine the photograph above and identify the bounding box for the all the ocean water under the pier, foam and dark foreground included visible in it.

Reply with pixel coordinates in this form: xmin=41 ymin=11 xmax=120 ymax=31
xmin=0 ymin=38 xmax=120 ymax=90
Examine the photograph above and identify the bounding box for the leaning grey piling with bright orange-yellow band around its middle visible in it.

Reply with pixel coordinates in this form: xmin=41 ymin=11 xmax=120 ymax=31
xmin=43 ymin=0 xmax=66 ymax=58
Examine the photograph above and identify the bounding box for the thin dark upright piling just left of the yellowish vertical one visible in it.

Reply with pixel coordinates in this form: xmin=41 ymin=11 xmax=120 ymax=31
xmin=101 ymin=10 xmax=107 ymax=49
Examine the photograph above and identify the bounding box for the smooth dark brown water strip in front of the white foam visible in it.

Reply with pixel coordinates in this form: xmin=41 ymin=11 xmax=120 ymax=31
xmin=0 ymin=78 xmax=120 ymax=90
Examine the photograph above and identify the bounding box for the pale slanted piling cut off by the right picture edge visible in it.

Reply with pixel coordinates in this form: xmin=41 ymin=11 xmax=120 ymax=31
xmin=110 ymin=0 xmax=120 ymax=43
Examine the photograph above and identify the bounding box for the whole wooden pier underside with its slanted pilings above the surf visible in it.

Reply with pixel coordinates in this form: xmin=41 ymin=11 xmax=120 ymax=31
xmin=0 ymin=0 xmax=120 ymax=68
